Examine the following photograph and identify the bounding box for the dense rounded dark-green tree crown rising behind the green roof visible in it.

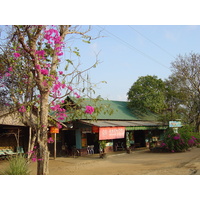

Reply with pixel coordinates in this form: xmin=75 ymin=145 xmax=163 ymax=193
xmin=127 ymin=75 xmax=165 ymax=113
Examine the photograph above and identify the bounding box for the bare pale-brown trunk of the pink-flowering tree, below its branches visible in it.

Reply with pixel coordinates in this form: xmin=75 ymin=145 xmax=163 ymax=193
xmin=37 ymin=92 xmax=49 ymax=175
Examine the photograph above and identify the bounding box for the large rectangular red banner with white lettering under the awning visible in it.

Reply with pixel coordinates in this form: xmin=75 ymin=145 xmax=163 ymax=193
xmin=99 ymin=127 xmax=125 ymax=140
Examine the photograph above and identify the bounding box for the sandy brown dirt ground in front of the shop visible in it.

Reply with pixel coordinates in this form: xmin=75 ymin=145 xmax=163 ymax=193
xmin=0 ymin=148 xmax=200 ymax=175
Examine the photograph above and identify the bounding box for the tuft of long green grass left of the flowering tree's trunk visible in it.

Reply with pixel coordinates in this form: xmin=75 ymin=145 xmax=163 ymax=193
xmin=2 ymin=154 xmax=30 ymax=175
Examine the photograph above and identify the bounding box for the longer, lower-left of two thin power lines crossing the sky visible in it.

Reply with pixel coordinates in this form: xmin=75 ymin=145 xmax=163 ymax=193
xmin=98 ymin=25 xmax=169 ymax=69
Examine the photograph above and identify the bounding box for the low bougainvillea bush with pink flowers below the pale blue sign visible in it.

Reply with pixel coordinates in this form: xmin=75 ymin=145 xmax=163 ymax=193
xmin=161 ymin=128 xmax=200 ymax=152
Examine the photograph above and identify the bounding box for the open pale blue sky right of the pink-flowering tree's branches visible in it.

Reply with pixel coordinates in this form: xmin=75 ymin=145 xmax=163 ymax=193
xmin=66 ymin=25 xmax=200 ymax=100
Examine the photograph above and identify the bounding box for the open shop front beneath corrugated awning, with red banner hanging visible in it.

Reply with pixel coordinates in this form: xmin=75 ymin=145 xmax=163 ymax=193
xmin=72 ymin=120 xmax=166 ymax=155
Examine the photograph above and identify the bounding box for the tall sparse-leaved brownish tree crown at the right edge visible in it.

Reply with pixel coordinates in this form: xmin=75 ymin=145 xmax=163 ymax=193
xmin=166 ymin=53 xmax=200 ymax=132
